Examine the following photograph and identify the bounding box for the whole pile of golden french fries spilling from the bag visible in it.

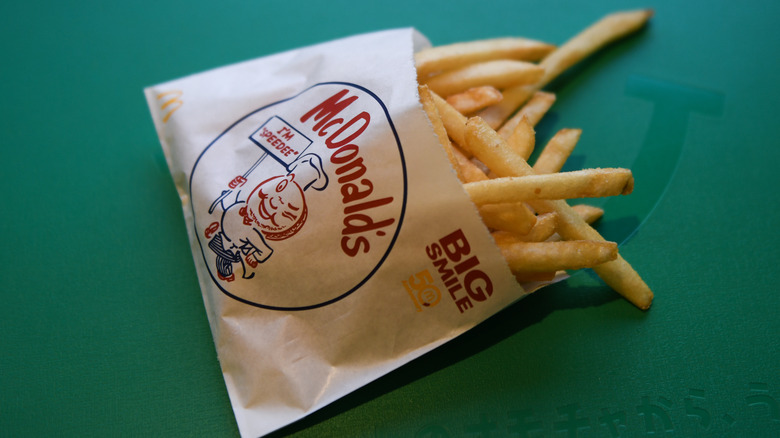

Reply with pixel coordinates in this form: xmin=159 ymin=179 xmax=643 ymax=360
xmin=415 ymin=10 xmax=653 ymax=309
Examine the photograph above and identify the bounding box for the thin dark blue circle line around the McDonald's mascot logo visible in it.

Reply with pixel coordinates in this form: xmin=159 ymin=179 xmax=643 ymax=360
xmin=189 ymin=81 xmax=408 ymax=311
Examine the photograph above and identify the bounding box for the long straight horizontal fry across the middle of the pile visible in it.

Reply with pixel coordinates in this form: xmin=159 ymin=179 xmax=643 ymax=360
xmin=463 ymin=169 xmax=634 ymax=205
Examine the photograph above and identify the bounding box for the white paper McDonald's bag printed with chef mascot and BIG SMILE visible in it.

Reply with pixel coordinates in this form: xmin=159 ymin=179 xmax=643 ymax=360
xmin=145 ymin=29 xmax=526 ymax=437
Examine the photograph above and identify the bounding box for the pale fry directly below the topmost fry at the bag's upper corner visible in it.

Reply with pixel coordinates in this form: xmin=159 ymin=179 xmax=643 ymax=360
xmin=423 ymin=59 xmax=544 ymax=97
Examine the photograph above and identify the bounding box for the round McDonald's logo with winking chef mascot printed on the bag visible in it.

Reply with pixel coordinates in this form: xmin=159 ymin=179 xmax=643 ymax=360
xmin=190 ymin=82 xmax=407 ymax=310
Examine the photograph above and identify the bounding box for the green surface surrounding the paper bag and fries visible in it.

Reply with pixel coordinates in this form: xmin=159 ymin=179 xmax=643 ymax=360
xmin=0 ymin=0 xmax=780 ymax=437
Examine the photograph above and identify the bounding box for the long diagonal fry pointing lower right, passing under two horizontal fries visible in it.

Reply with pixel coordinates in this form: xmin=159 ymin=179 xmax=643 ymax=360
xmin=462 ymin=117 xmax=653 ymax=309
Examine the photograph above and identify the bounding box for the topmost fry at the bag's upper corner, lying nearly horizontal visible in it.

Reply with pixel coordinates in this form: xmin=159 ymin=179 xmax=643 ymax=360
xmin=414 ymin=38 xmax=555 ymax=78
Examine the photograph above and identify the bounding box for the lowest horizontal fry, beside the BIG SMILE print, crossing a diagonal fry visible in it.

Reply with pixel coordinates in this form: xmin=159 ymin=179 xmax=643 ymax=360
xmin=499 ymin=240 xmax=618 ymax=272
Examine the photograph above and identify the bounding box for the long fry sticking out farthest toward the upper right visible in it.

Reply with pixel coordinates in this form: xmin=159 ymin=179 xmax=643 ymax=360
xmin=479 ymin=10 xmax=653 ymax=128
